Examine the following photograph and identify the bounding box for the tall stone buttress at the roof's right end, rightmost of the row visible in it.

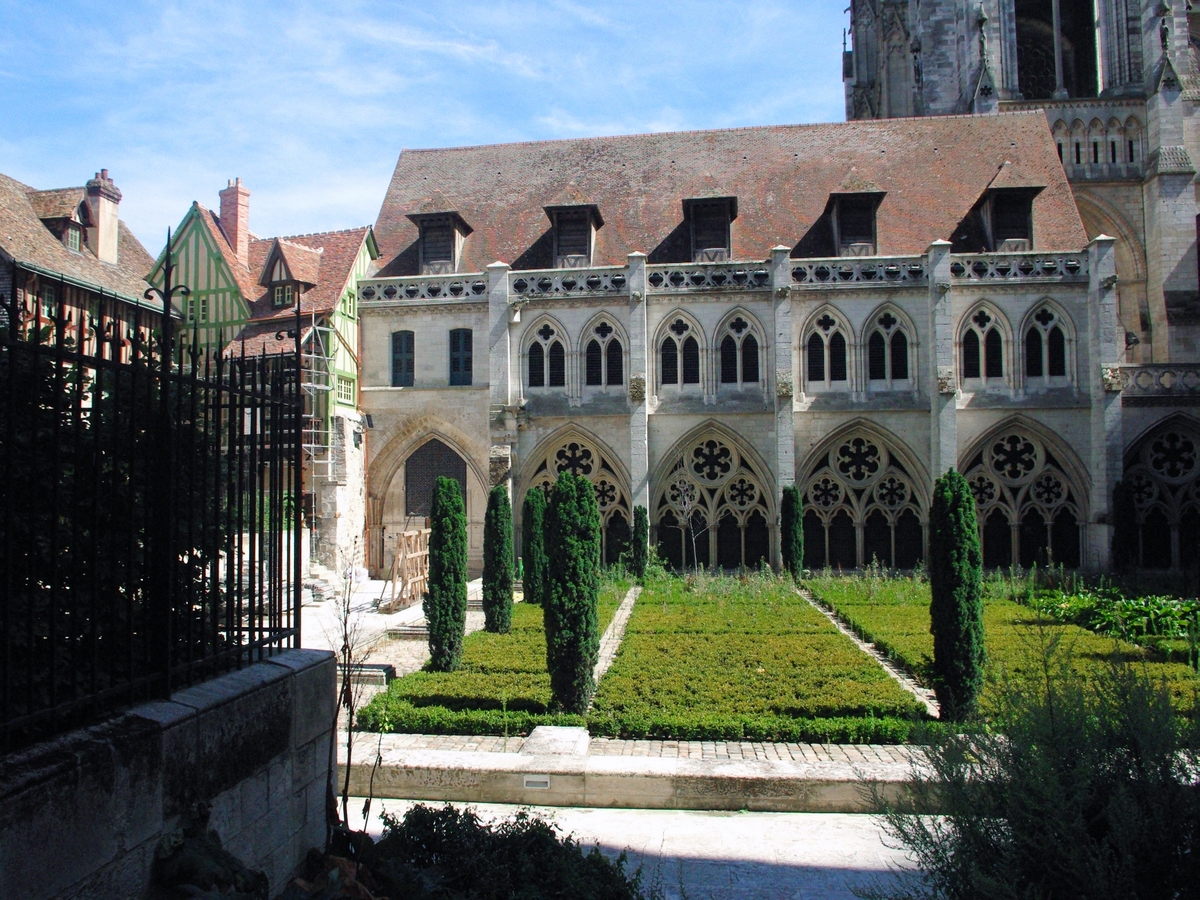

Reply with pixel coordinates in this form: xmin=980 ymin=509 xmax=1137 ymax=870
xmin=1082 ymin=234 xmax=1124 ymax=570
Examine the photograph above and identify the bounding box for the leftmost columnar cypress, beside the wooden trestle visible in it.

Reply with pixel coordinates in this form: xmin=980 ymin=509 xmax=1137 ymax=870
xmin=422 ymin=478 xmax=467 ymax=672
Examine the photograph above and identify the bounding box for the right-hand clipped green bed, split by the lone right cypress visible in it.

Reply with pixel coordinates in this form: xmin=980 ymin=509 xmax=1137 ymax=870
xmin=805 ymin=576 xmax=1200 ymax=709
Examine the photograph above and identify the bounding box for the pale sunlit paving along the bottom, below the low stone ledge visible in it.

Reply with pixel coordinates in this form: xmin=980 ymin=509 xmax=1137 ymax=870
xmin=349 ymin=798 xmax=911 ymax=900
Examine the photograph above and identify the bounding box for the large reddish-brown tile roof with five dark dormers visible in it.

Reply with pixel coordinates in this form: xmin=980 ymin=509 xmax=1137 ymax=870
xmin=376 ymin=110 xmax=1087 ymax=275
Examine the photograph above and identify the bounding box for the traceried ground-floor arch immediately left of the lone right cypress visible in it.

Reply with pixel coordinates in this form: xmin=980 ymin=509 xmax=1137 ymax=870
xmin=797 ymin=418 xmax=929 ymax=569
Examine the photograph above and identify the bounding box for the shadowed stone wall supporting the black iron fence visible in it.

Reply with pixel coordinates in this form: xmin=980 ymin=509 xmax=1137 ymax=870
xmin=0 ymin=650 xmax=336 ymax=900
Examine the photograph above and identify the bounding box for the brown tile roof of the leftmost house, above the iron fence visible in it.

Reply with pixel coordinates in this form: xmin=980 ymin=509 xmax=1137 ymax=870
xmin=0 ymin=175 xmax=155 ymax=306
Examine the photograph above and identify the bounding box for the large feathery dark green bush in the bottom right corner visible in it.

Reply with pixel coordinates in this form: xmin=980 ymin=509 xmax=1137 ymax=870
xmin=863 ymin=641 xmax=1200 ymax=900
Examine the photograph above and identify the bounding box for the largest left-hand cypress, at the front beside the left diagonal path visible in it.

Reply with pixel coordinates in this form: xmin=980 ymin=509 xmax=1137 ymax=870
xmin=545 ymin=473 xmax=600 ymax=714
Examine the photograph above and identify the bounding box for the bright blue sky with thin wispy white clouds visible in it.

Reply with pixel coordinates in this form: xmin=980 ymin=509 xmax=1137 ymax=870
xmin=0 ymin=0 xmax=847 ymax=252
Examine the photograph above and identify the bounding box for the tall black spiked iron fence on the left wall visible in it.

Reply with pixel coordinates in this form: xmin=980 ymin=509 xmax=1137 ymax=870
xmin=0 ymin=250 xmax=304 ymax=750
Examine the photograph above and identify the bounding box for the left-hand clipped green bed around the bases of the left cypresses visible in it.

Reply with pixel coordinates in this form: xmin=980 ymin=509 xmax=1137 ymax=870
xmin=358 ymin=581 xmax=630 ymax=734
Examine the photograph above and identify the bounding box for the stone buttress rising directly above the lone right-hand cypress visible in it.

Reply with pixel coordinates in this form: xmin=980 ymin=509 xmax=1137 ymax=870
xmin=925 ymin=241 xmax=959 ymax=480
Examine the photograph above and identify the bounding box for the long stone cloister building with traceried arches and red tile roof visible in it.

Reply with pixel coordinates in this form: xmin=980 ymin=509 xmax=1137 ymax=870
xmin=359 ymin=110 xmax=1200 ymax=571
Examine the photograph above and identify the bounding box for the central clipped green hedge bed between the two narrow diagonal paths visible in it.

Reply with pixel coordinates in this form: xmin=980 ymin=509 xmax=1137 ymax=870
xmin=588 ymin=575 xmax=924 ymax=743
